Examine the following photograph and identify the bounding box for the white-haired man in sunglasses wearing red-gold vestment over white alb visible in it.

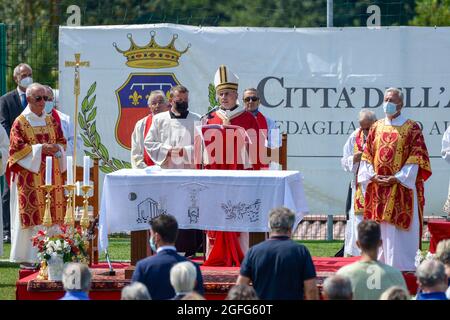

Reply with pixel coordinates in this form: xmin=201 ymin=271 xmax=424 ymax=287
xmin=8 ymin=83 xmax=66 ymax=266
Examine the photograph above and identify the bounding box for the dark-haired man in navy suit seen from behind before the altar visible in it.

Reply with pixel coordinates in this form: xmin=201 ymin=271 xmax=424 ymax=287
xmin=132 ymin=214 xmax=204 ymax=300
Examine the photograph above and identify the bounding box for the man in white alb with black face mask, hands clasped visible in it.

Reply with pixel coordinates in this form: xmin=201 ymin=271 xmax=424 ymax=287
xmin=144 ymin=85 xmax=200 ymax=169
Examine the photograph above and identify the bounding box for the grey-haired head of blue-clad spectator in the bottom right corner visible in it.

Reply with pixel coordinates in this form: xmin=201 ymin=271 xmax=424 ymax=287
xmin=416 ymin=260 xmax=447 ymax=291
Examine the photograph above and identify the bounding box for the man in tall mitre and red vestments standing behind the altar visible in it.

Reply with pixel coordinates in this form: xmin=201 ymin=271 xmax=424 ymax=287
xmin=202 ymin=65 xmax=261 ymax=266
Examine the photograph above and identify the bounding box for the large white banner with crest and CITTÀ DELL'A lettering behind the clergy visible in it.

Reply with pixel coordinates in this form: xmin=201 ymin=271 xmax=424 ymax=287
xmin=59 ymin=24 xmax=450 ymax=215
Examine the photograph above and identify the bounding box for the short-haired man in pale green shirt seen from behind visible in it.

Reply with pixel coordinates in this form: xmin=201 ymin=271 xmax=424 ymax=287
xmin=337 ymin=220 xmax=407 ymax=300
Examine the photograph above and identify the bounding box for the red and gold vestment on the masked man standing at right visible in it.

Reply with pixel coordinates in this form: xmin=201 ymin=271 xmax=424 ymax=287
xmin=361 ymin=119 xmax=431 ymax=234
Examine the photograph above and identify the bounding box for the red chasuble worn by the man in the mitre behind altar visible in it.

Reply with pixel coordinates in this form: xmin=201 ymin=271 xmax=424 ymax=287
xmin=203 ymin=111 xmax=260 ymax=267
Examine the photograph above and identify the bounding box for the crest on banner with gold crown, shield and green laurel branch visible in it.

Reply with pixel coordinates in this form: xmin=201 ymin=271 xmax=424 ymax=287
xmin=78 ymin=31 xmax=190 ymax=173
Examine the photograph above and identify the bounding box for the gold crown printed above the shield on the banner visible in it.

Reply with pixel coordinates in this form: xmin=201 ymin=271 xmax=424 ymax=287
xmin=113 ymin=31 xmax=191 ymax=69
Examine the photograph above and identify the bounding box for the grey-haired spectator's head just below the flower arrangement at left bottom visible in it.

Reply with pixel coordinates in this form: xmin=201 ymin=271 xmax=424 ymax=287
xmin=62 ymin=262 xmax=92 ymax=292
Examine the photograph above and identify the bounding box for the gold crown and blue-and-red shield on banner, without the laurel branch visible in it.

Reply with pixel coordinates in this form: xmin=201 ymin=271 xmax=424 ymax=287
xmin=113 ymin=31 xmax=190 ymax=149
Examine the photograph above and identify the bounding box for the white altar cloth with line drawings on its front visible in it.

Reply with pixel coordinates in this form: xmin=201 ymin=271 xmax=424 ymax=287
xmin=99 ymin=167 xmax=308 ymax=250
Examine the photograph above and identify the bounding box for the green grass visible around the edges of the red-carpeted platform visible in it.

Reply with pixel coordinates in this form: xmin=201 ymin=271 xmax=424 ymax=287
xmin=0 ymin=237 xmax=429 ymax=300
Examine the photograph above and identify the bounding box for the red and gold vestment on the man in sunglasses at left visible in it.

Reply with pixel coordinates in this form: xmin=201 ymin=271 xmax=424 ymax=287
xmin=8 ymin=115 xmax=66 ymax=228
